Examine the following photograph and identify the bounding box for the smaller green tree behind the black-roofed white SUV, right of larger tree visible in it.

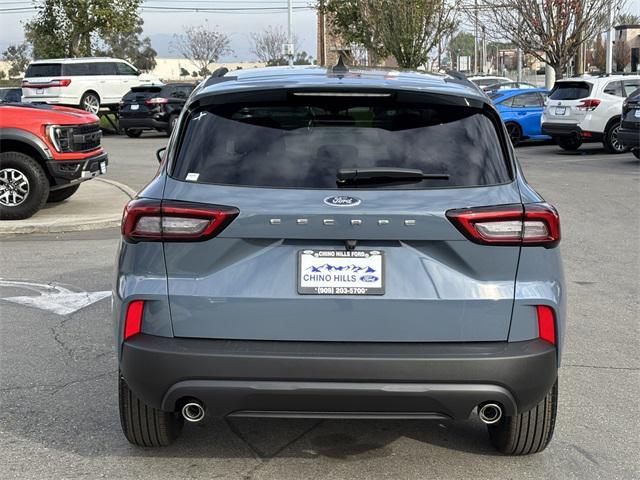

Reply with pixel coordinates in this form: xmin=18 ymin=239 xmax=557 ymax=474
xmin=96 ymin=19 xmax=158 ymax=72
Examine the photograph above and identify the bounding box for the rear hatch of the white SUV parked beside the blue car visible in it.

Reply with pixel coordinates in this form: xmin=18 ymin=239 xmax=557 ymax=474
xmin=546 ymin=80 xmax=593 ymax=124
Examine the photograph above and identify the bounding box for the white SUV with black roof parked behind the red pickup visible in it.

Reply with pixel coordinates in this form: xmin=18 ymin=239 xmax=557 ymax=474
xmin=22 ymin=57 xmax=161 ymax=114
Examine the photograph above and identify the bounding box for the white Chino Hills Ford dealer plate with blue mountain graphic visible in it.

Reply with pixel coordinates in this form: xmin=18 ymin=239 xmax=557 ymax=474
xmin=298 ymin=250 xmax=384 ymax=295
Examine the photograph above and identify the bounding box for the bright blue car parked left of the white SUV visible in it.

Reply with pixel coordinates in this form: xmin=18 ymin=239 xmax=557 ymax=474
xmin=489 ymin=88 xmax=551 ymax=145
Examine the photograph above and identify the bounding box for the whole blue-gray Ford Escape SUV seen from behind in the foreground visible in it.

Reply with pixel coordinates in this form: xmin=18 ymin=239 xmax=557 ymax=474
xmin=114 ymin=63 xmax=565 ymax=455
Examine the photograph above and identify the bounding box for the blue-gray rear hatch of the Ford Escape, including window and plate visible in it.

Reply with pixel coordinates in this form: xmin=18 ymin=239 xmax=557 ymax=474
xmin=163 ymin=94 xmax=521 ymax=342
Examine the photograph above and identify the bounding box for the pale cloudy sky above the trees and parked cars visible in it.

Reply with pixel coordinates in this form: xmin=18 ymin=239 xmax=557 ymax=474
xmin=0 ymin=0 xmax=640 ymax=62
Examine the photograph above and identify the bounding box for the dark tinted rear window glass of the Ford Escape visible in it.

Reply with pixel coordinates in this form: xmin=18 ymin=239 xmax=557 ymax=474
xmin=173 ymin=97 xmax=510 ymax=189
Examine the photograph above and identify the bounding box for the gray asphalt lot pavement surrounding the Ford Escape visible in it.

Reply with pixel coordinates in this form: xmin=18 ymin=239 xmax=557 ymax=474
xmin=0 ymin=134 xmax=640 ymax=479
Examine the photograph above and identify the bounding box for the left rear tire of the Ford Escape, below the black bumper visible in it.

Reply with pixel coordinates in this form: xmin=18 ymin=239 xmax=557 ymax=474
xmin=118 ymin=377 xmax=184 ymax=447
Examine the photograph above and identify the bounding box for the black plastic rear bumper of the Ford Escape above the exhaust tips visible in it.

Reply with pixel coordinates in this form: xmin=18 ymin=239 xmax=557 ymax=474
xmin=120 ymin=334 xmax=557 ymax=419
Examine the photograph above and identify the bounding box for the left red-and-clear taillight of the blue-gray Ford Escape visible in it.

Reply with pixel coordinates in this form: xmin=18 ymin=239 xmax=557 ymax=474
xmin=121 ymin=199 xmax=240 ymax=242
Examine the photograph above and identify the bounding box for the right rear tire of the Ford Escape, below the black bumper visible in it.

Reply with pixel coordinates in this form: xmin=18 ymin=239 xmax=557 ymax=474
xmin=487 ymin=380 xmax=558 ymax=455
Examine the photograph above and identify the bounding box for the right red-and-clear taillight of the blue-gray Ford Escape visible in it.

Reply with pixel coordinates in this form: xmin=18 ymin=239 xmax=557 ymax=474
xmin=446 ymin=203 xmax=560 ymax=248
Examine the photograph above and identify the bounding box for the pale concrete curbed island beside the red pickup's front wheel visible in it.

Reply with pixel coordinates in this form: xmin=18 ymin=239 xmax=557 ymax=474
xmin=0 ymin=178 xmax=136 ymax=237
